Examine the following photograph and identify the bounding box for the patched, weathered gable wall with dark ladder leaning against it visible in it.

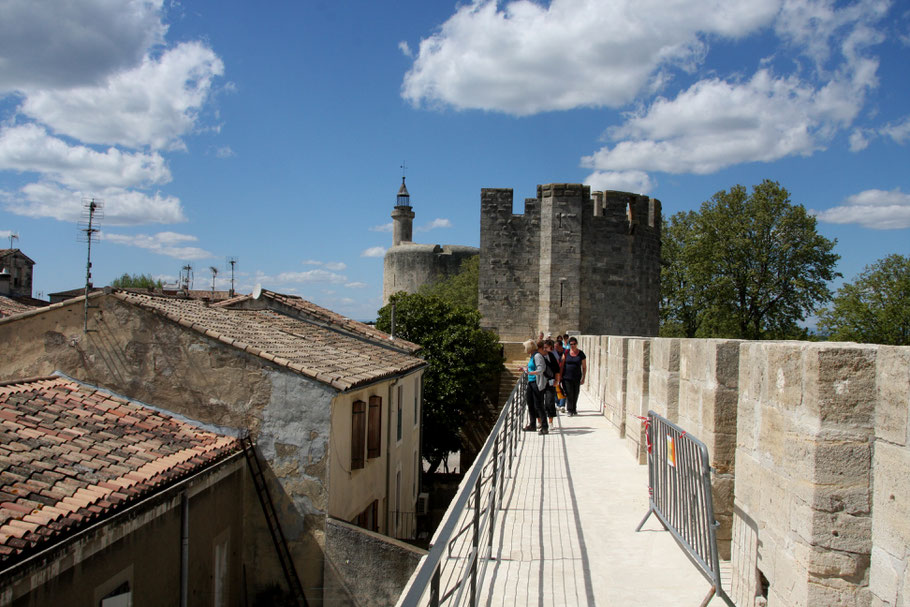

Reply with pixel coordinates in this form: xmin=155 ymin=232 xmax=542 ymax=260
xmin=0 ymin=295 xmax=335 ymax=593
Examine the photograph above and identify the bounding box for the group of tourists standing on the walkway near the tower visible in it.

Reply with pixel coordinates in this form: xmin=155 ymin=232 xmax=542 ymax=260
xmin=523 ymin=332 xmax=588 ymax=434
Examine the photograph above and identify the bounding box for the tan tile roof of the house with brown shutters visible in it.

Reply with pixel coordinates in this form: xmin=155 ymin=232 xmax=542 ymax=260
xmin=113 ymin=291 xmax=426 ymax=390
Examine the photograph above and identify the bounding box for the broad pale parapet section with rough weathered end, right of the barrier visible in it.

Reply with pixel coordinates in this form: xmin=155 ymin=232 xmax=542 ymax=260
xmin=732 ymin=342 xmax=880 ymax=606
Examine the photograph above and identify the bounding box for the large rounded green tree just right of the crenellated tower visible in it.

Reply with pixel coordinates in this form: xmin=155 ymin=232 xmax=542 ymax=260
xmin=661 ymin=180 xmax=840 ymax=339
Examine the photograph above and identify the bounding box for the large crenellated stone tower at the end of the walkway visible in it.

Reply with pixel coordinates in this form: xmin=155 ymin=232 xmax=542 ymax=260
xmin=479 ymin=183 xmax=661 ymax=341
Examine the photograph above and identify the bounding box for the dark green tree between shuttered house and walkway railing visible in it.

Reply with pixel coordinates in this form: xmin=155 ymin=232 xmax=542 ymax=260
xmin=376 ymin=292 xmax=502 ymax=471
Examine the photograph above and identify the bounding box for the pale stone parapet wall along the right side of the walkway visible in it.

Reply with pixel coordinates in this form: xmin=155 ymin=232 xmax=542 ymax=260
xmin=579 ymin=336 xmax=910 ymax=607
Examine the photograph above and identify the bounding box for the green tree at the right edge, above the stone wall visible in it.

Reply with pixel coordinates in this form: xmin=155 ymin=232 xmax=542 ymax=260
xmin=818 ymin=255 xmax=910 ymax=346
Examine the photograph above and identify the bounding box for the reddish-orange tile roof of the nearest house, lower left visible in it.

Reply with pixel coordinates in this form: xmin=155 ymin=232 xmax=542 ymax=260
xmin=0 ymin=377 xmax=240 ymax=568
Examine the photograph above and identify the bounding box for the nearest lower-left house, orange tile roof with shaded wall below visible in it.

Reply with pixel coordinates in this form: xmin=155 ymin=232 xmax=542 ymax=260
xmin=0 ymin=376 xmax=246 ymax=607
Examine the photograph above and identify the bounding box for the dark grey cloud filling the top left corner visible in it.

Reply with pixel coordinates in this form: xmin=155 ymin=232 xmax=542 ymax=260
xmin=0 ymin=0 xmax=167 ymax=94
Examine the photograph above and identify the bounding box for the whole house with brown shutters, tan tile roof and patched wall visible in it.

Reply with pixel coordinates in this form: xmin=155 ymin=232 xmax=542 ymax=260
xmin=0 ymin=289 xmax=425 ymax=603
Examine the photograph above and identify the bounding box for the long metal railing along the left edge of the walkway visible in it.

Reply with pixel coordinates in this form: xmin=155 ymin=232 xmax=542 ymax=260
xmin=396 ymin=375 xmax=527 ymax=607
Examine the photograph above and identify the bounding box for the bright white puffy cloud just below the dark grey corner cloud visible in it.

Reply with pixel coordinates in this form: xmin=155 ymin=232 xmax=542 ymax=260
xmin=20 ymin=42 xmax=224 ymax=149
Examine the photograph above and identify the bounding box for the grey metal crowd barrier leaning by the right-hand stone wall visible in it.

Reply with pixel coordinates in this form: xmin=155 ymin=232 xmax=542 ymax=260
xmin=635 ymin=411 xmax=735 ymax=607
